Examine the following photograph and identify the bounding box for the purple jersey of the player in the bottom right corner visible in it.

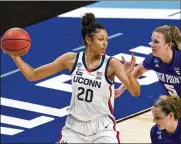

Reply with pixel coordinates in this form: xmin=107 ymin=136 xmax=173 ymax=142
xmin=150 ymin=120 xmax=181 ymax=144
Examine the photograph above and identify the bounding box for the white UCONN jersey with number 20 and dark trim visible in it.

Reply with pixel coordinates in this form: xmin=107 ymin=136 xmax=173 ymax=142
xmin=67 ymin=52 xmax=114 ymax=121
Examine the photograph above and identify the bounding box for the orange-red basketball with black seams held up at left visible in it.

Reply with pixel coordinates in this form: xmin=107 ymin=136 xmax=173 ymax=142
xmin=1 ymin=28 xmax=31 ymax=56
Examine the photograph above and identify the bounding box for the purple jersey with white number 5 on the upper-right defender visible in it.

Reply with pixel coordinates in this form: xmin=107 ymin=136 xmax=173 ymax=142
xmin=143 ymin=49 xmax=181 ymax=98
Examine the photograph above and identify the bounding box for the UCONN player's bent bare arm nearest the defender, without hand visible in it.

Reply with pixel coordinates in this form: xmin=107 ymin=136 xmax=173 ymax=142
xmin=110 ymin=58 xmax=140 ymax=96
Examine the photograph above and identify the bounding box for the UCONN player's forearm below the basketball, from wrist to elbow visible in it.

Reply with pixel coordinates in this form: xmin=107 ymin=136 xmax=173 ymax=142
xmin=11 ymin=56 xmax=34 ymax=81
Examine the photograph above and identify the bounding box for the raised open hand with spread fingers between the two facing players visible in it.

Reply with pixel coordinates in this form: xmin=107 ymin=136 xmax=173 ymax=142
xmin=122 ymin=54 xmax=136 ymax=75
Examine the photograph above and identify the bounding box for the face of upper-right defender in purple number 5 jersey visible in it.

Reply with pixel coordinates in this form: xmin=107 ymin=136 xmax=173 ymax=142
xmin=151 ymin=32 xmax=169 ymax=57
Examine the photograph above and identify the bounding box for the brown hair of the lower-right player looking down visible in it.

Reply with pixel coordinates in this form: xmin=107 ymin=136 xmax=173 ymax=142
xmin=153 ymin=95 xmax=181 ymax=120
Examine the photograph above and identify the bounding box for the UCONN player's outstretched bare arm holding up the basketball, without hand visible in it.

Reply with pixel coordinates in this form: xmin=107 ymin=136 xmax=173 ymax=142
xmin=11 ymin=52 xmax=76 ymax=81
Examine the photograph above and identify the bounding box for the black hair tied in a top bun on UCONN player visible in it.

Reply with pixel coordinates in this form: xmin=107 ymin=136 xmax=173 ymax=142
xmin=81 ymin=13 xmax=105 ymax=45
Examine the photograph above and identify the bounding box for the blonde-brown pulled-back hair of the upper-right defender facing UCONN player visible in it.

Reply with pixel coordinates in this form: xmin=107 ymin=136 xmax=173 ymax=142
xmin=154 ymin=25 xmax=181 ymax=51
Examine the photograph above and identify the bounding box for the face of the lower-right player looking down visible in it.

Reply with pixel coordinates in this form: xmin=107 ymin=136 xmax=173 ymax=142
xmin=151 ymin=106 xmax=169 ymax=130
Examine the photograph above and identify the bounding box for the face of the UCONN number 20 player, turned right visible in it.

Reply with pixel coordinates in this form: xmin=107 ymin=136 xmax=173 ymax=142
xmin=90 ymin=29 xmax=108 ymax=56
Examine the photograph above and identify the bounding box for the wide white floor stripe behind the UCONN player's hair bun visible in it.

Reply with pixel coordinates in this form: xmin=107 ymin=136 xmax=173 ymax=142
xmin=57 ymin=7 xmax=180 ymax=20
